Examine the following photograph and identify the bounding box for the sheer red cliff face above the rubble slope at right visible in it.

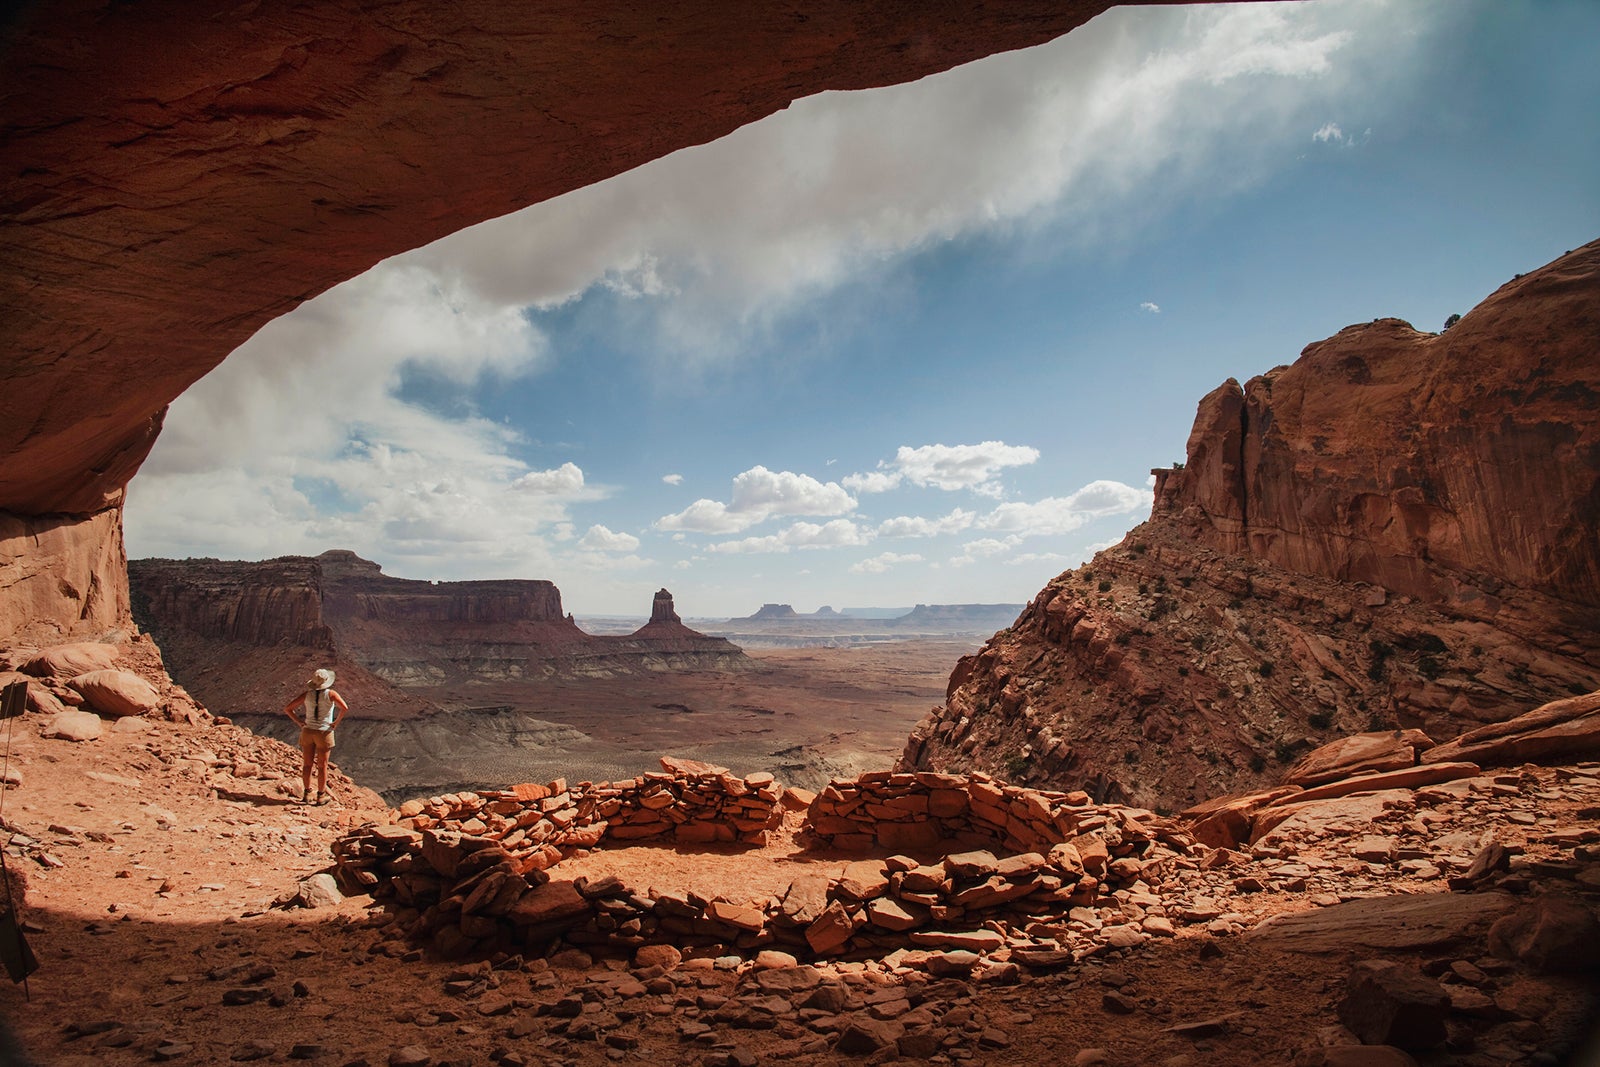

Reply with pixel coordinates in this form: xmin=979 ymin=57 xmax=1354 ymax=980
xmin=1155 ymin=245 xmax=1600 ymax=611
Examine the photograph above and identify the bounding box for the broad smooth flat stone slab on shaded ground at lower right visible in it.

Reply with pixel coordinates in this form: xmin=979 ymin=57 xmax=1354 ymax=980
xmin=1245 ymin=893 xmax=1517 ymax=953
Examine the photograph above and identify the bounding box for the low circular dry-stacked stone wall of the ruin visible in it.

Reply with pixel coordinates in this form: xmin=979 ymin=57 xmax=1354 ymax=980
xmin=334 ymin=761 xmax=1213 ymax=968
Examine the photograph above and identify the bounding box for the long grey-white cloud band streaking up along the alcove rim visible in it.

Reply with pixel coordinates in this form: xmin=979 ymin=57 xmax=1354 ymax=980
xmin=390 ymin=3 xmax=1426 ymax=368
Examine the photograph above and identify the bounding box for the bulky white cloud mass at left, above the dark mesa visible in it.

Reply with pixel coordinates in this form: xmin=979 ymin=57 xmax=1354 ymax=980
xmin=126 ymin=261 xmax=624 ymax=577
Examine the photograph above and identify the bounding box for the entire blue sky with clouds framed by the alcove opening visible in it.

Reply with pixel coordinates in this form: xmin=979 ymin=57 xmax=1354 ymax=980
xmin=126 ymin=0 xmax=1600 ymax=616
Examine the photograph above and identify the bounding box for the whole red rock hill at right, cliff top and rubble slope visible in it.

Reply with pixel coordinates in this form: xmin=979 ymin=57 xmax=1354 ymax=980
xmin=901 ymin=242 xmax=1600 ymax=806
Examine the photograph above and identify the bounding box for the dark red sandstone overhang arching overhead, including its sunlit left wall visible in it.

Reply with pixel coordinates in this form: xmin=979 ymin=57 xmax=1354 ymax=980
xmin=0 ymin=0 xmax=1158 ymax=641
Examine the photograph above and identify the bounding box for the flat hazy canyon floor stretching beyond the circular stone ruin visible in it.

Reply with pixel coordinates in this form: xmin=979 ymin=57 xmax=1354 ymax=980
xmin=230 ymin=640 xmax=978 ymax=803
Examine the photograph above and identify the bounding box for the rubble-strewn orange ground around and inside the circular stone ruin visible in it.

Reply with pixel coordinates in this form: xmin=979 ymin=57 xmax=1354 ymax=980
xmin=0 ymin=694 xmax=1600 ymax=1065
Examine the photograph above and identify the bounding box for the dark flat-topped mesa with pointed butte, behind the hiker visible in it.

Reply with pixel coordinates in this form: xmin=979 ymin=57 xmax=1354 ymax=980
xmin=128 ymin=550 xmax=750 ymax=718
